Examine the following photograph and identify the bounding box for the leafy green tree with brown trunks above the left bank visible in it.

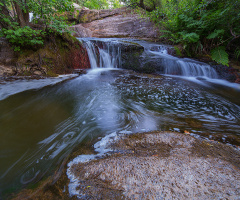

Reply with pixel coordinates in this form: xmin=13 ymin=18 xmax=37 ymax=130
xmin=0 ymin=0 xmax=72 ymax=50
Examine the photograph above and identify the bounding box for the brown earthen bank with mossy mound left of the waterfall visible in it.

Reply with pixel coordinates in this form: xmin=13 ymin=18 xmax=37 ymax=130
xmin=0 ymin=34 xmax=90 ymax=77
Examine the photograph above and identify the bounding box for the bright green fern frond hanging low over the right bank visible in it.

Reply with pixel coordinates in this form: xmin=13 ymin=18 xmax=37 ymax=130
xmin=211 ymin=46 xmax=229 ymax=66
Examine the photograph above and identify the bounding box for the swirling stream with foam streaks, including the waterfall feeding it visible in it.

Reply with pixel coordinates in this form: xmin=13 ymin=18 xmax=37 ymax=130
xmin=0 ymin=38 xmax=240 ymax=198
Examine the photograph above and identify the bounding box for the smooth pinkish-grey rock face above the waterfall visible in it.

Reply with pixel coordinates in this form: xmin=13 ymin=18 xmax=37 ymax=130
xmin=73 ymin=8 xmax=159 ymax=40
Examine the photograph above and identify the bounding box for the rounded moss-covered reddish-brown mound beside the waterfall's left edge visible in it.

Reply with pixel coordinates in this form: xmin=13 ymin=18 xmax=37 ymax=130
xmin=11 ymin=33 xmax=90 ymax=76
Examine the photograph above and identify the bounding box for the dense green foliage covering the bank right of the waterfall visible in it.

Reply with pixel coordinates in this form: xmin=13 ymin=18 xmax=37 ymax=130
xmin=147 ymin=0 xmax=240 ymax=64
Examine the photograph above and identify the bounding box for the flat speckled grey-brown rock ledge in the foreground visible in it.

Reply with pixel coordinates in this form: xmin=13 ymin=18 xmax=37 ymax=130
xmin=70 ymin=132 xmax=240 ymax=199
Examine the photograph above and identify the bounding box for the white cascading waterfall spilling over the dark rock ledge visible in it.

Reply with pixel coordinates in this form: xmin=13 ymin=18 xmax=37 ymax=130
xmin=79 ymin=38 xmax=218 ymax=78
